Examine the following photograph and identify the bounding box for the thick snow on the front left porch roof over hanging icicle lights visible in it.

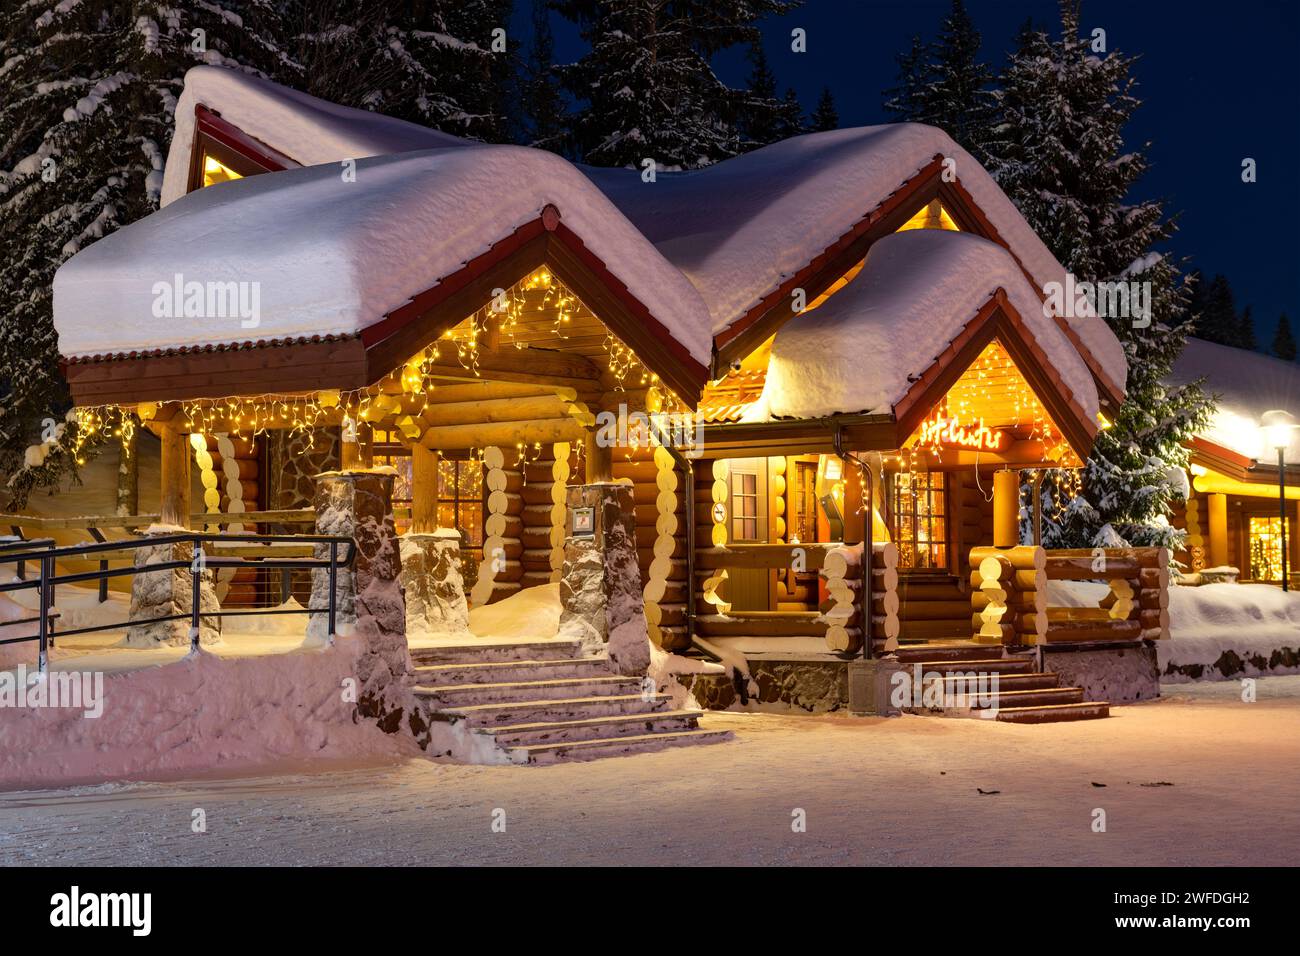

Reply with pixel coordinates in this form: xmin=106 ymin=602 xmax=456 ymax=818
xmin=55 ymin=144 xmax=712 ymax=365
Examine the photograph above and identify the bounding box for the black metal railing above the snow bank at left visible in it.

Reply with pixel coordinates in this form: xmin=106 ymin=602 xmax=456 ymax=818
xmin=0 ymin=532 xmax=356 ymax=672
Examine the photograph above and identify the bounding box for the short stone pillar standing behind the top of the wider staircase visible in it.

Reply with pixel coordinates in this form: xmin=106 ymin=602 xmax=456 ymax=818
xmin=400 ymin=528 xmax=469 ymax=639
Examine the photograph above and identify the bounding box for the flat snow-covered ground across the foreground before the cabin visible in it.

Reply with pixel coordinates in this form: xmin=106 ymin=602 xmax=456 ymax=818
xmin=0 ymin=676 xmax=1300 ymax=866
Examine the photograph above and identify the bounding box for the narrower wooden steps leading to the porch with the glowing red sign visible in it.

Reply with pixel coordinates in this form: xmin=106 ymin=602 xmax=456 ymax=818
xmin=897 ymin=644 xmax=1110 ymax=723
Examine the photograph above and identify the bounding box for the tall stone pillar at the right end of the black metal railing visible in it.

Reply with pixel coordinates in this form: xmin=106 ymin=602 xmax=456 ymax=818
xmin=307 ymin=471 xmax=412 ymax=734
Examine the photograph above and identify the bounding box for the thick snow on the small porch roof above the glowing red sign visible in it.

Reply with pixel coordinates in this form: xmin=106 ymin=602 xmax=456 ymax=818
xmin=746 ymin=229 xmax=1097 ymax=420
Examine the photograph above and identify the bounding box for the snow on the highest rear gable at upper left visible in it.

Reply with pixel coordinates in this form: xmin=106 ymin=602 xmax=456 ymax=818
xmin=163 ymin=66 xmax=473 ymax=206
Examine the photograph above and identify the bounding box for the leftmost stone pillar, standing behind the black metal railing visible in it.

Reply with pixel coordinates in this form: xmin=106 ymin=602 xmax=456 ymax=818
xmin=126 ymin=535 xmax=221 ymax=648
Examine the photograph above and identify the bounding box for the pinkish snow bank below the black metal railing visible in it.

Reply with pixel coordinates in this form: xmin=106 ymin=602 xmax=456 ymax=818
xmin=0 ymin=637 xmax=416 ymax=790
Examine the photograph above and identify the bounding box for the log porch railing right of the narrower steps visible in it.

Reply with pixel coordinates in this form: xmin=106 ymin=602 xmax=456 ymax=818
xmin=970 ymin=546 xmax=1170 ymax=645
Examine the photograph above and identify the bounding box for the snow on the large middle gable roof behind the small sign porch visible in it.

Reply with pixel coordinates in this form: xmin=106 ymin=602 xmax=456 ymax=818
xmin=584 ymin=124 xmax=1127 ymax=388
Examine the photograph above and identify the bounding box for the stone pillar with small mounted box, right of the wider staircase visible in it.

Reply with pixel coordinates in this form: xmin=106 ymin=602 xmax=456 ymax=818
xmin=559 ymin=483 xmax=650 ymax=674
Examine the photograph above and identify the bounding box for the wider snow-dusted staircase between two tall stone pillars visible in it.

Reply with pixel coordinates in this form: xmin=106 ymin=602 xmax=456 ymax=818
xmin=411 ymin=640 xmax=732 ymax=763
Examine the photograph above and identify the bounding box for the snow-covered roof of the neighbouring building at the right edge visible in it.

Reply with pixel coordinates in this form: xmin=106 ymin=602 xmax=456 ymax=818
xmin=1169 ymin=338 xmax=1300 ymax=464
